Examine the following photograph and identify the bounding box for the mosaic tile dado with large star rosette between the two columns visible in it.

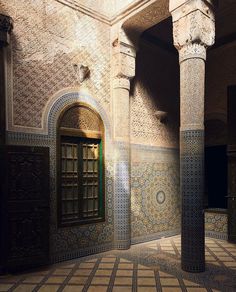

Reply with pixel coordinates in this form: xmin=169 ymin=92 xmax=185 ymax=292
xmin=131 ymin=161 xmax=181 ymax=242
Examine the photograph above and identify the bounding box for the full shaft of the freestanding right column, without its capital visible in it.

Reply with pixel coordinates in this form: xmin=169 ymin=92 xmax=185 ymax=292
xmin=180 ymin=52 xmax=205 ymax=272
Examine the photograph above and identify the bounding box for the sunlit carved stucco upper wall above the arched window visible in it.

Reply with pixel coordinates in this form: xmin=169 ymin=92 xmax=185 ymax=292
xmin=0 ymin=0 xmax=110 ymax=128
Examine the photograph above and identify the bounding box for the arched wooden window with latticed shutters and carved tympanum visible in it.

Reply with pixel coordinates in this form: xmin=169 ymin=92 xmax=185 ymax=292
xmin=56 ymin=102 xmax=105 ymax=227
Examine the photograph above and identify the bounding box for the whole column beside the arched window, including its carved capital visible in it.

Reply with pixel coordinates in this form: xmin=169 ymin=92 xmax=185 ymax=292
xmin=113 ymin=34 xmax=135 ymax=249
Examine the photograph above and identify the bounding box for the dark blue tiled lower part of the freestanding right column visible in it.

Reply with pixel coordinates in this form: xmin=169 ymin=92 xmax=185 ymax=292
xmin=180 ymin=130 xmax=205 ymax=272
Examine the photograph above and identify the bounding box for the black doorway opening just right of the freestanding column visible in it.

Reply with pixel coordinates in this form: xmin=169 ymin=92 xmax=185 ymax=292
xmin=205 ymin=145 xmax=228 ymax=209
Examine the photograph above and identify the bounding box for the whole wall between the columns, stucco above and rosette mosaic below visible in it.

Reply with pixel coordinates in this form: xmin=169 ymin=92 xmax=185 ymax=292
xmin=131 ymin=42 xmax=180 ymax=243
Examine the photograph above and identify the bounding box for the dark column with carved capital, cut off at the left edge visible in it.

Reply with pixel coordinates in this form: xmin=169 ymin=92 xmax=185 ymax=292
xmin=0 ymin=14 xmax=13 ymax=145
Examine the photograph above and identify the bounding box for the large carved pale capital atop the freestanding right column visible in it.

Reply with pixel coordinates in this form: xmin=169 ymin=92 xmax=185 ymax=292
xmin=170 ymin=0 xmax=215 ymax=60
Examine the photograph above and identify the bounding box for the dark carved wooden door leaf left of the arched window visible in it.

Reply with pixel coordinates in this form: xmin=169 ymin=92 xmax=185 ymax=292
xmin=5 ymin=146 xmax=49 ymax=270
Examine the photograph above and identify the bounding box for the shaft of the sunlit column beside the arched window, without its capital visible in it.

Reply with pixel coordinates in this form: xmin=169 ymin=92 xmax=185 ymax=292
xmin=113 ymin=78 xmax=131 ymax=249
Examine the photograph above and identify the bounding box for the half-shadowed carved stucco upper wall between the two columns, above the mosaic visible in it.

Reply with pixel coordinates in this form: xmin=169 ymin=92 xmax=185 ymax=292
xmin=131 ymin=43 xmax=179 ymax=147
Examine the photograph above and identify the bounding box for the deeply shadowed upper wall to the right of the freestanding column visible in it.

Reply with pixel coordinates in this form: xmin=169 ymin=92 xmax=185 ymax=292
xmin=205 ymin=43 xmax=236 ymax=145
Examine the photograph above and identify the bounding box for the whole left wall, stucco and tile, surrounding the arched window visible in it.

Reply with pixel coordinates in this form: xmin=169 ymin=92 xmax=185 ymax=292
xmin=0 ymin=0 xmax=113 ymax=261
